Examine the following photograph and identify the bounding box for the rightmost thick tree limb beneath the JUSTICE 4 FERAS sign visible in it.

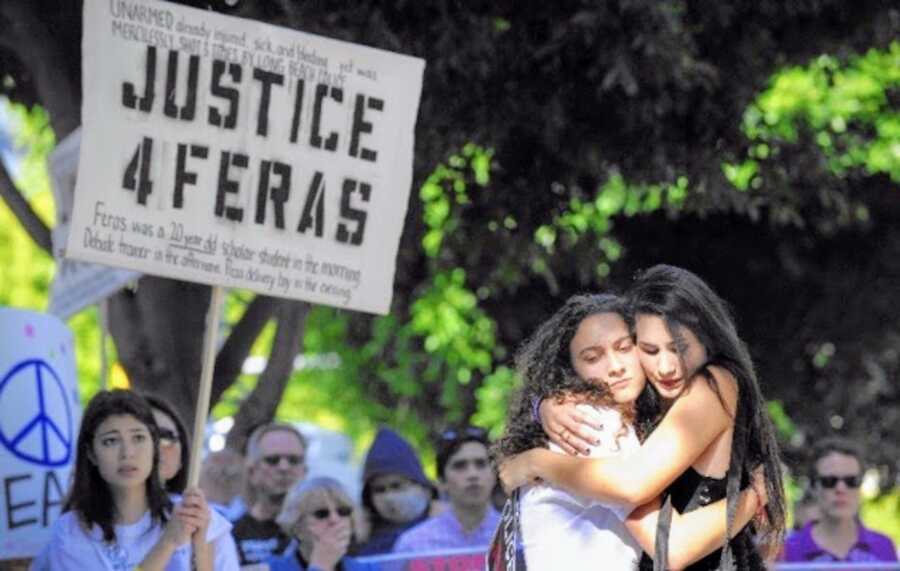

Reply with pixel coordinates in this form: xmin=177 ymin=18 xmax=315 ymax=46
xmin=228 ymin=301 xmax=310 ymax=450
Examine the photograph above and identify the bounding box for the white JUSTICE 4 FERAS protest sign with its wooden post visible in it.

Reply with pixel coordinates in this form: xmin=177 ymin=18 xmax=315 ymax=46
xmin=67 ymin=0 xmax=425 ymax=483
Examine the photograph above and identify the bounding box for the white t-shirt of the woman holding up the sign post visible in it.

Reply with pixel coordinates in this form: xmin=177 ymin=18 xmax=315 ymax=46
xmin=46 ymin=498 xmax=240 ymax=571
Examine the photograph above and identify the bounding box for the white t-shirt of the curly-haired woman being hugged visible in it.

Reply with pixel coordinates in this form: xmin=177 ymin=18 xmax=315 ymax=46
xmin=521 ymin=404 xmax=641 ymax=571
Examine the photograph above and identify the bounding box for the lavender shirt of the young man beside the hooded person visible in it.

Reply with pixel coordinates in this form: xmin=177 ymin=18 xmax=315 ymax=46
xmin=394 ymin=506 xmax=500 ymax=553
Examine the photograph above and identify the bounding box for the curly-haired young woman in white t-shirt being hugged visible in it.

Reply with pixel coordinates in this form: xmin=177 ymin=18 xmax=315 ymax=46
xmin=494 ymin=295 xmax=759 ymax=571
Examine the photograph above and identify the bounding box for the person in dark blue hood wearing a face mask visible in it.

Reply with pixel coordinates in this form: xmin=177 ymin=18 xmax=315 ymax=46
xmin=354 ymin=427 xmax=437 ymax=556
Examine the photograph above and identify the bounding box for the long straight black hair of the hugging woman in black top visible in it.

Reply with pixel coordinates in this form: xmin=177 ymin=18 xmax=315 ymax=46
xmin=628 ymin=264 xmax=785 ymax=567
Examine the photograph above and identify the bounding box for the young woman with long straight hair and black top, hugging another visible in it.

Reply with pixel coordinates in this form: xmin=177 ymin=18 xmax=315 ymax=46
xmin=501 ymin=265 xmax=784 ymax=570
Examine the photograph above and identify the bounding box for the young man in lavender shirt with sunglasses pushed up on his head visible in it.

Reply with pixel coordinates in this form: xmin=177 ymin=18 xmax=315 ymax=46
xmin=394 ymin=426 xmax=500 ymax=565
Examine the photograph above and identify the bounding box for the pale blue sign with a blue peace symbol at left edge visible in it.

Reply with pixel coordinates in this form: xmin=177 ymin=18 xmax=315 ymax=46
xmin=0 ymin=308 xmax=81 ymax=559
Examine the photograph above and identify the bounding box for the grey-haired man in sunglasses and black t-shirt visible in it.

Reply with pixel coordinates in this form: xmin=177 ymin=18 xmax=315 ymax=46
xmin=232 ymin=423 xmax=307 ymax=565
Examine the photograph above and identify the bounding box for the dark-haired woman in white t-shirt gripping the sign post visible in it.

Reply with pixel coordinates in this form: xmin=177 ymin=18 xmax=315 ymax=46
xmin=49 ymin=390 xmax=238 ymax=571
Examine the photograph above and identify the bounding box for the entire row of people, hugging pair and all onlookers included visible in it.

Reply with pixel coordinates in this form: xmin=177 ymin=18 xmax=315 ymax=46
xmin=24 ymin=266 xmax=897 ymax=571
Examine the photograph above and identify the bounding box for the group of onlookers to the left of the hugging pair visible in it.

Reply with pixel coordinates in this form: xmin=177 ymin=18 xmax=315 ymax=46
xmin=31 ymin=389 xmax=499 ymax=571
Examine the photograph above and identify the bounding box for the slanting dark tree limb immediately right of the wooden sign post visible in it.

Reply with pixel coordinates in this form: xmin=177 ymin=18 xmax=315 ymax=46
xmin=210 ymin=295 xmax=278 ymax=404
